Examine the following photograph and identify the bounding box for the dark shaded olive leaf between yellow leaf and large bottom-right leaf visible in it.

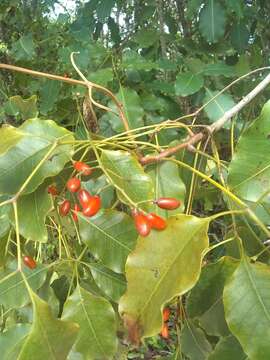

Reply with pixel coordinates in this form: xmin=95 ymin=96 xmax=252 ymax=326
xmin=187 ymin=257 xmax=237 ymax=336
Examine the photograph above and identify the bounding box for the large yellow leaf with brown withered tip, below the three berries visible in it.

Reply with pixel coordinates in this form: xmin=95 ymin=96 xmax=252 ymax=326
xmin=119 ymin=215 xmax=209 ymax=342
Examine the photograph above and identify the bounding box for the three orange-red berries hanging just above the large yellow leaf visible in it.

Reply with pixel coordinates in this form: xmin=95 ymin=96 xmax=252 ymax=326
xmin=132 ymin=198 xmax=181 ymax=236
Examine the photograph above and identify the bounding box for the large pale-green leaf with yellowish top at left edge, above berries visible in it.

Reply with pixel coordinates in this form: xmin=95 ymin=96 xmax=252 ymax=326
xmin=0 ymin=119 xmax=74 ymax=195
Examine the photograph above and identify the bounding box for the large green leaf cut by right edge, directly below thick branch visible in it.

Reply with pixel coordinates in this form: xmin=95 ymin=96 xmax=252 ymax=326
xmin=228 ymin=101 xmax=270 ymax=202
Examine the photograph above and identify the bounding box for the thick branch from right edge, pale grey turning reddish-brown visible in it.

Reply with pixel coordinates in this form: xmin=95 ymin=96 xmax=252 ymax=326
xmin=140 ymin=74 xmax=270 ymax=165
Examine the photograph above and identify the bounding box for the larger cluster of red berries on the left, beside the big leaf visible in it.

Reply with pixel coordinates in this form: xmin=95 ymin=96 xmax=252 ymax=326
xmin=48 ymin=161 xmax=101 ymax=221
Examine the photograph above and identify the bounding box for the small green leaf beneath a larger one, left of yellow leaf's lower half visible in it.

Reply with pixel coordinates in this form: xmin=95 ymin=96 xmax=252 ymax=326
xmin=88 ymin=263 xmax=126 ymax=303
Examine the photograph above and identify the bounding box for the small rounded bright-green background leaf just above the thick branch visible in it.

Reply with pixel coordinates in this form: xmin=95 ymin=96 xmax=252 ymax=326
xmin=175 ymin=72 xmax=203 ymax=96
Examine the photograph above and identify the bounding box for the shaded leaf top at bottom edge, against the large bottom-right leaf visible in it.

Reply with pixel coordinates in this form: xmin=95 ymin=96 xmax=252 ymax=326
xmin=208 ymin=335 xmax=248 ymax=360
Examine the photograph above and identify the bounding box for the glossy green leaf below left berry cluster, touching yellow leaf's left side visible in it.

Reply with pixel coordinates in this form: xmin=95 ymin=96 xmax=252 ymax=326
xmin=78 ymin=210 xmax=137 ymax=273
